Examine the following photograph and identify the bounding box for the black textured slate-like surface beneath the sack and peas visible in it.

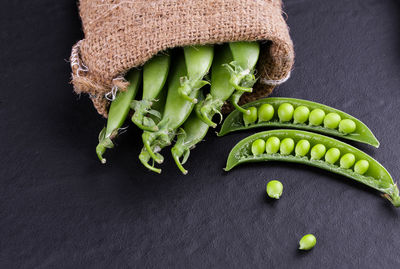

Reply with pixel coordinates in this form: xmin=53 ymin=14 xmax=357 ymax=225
xmin=0 ymin=0 xmax=400 ymax=268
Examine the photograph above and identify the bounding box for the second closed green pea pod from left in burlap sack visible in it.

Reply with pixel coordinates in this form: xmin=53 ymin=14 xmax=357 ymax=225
xmin=131 ymin=54 xmax=170 ymax=131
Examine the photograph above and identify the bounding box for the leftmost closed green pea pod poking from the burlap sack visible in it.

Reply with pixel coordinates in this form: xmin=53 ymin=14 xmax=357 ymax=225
xmin=96 ymin=69 xmax=141 ymax=163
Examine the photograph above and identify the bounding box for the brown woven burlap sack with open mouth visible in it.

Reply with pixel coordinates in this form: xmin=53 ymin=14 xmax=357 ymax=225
xmin=71 ymin=0 xmax=294 ymax=116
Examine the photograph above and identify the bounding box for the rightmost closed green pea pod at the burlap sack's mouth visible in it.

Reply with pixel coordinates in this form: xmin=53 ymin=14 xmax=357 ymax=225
xmin=224 ymin=42 xmax=260 ymax=113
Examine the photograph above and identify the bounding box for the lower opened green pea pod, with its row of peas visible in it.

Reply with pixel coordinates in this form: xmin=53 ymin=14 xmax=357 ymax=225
xmin=225 ymin=130 xmax=400 ymax=207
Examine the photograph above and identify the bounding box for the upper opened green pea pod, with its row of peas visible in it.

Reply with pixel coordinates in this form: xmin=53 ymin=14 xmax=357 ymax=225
xmin=218 ymin=97 xmax=379 ymax=147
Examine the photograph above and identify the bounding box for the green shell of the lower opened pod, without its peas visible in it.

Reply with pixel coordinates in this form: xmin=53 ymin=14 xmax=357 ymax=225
xmin=225 ymin=130 xmax=400 ymax=207
